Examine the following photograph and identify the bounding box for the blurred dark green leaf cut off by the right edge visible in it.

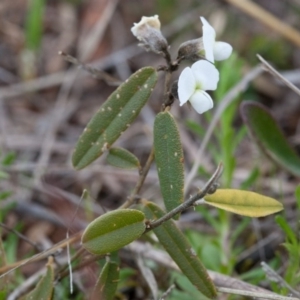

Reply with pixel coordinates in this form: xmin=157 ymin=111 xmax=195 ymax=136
xmin=241 ymin=101 xmax=300 ymax=177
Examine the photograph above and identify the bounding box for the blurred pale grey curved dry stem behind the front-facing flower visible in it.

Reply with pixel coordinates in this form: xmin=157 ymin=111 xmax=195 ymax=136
xmin=185 ymin=65 xmax=263 ymax=194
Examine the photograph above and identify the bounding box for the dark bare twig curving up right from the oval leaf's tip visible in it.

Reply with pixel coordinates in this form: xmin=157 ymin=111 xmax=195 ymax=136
xmin=148 ymin=163 xmax=223 ymax=230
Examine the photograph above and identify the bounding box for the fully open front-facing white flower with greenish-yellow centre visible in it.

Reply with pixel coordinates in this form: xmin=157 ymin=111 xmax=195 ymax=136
xmin=178 ymin=60 xmax=219 ymax=114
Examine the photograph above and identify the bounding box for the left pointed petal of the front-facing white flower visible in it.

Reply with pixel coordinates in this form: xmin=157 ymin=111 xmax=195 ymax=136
xmin=178 ymin=67 xmax=196 ymax=106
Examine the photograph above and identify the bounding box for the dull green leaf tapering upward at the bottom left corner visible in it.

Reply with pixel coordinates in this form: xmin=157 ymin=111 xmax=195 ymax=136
xmin=21 ymin=257 xmax=54 ymax=300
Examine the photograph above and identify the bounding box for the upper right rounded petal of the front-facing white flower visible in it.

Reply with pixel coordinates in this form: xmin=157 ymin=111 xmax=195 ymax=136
xmin=192 ymin=60 xmax=219 ymax=91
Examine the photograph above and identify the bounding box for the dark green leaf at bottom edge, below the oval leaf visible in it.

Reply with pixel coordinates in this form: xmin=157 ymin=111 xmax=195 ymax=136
xmin=92 ymin=261 xmax=119 ymax=300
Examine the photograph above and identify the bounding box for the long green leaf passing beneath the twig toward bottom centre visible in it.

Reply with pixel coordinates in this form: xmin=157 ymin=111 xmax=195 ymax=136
xmin=142 ymin=200 xmax=216 ymax=298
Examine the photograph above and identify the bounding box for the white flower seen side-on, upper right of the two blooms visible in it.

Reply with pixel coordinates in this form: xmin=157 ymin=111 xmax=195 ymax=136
xmin=200 ymin=17 xmax=232 ymax=62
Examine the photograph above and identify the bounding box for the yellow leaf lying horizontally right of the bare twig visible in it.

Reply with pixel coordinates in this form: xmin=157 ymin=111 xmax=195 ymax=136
xmin=204 ymin=189 xmax=283 ymax=217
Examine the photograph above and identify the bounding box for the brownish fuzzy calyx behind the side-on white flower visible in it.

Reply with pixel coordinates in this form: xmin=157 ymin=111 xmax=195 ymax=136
xmin=177 ymin=38 xmax=205 ymax=61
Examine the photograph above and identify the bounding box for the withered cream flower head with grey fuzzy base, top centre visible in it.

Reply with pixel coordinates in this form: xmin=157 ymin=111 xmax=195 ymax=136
xmin=131 ymin=15 xmax=168 ymax=54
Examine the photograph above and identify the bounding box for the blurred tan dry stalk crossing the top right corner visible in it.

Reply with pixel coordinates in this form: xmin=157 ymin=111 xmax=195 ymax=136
xmin=226 ymin=0 xmax=300 ymax=47
